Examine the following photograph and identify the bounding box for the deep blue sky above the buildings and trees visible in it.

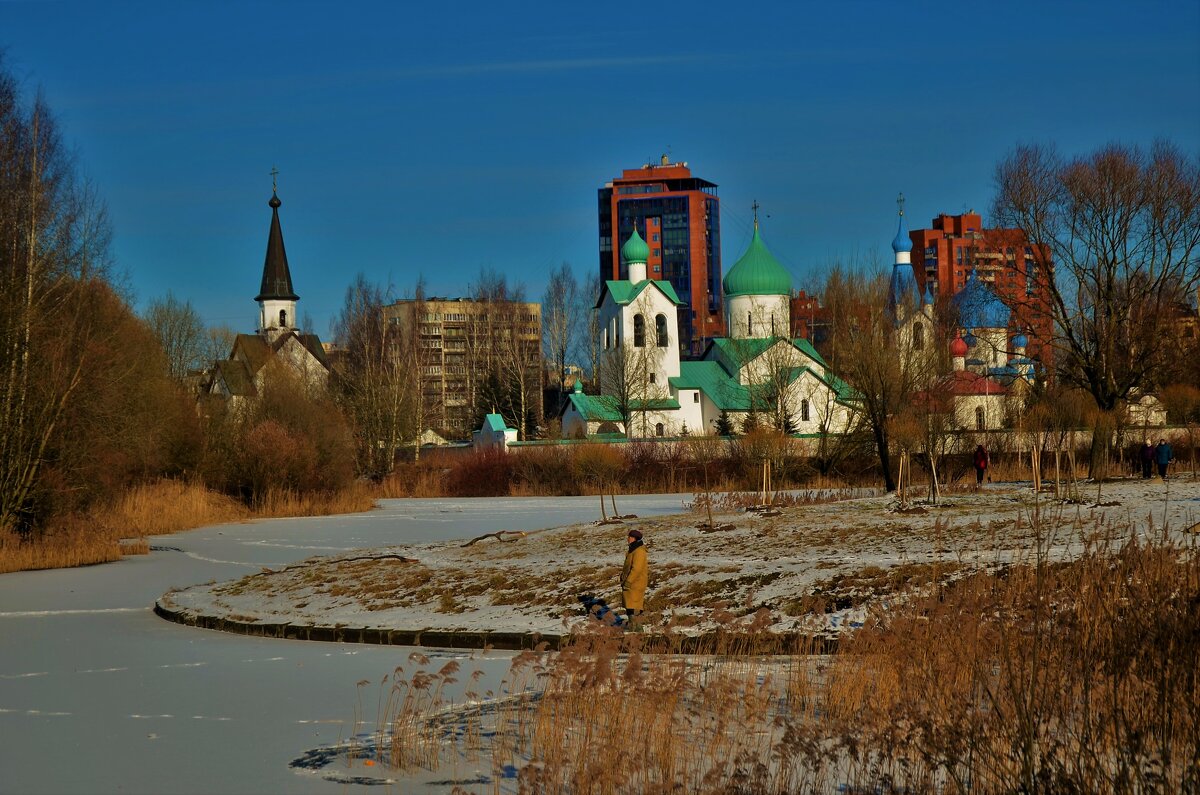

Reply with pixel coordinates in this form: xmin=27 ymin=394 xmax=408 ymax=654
xmin=0 ymin=0 xmax=1200 ymax=336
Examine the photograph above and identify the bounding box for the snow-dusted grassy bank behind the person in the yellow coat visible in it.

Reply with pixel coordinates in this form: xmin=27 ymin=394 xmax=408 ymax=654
xmin=161 ymin=479 xmax=1200 ymax=635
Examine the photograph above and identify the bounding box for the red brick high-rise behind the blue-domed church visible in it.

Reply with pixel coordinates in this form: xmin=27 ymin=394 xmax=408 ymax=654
xmin=908 ymin=210 xmax=1054 ymax=367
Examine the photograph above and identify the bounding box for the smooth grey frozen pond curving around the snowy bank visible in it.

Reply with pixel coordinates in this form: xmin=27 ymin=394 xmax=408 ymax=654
xmin=0 ymin=495 xmax=690 ymax=793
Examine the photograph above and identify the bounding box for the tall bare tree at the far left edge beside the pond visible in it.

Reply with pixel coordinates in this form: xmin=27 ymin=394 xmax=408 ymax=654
xmin=0 ymin=62 xmax=110 ymax=530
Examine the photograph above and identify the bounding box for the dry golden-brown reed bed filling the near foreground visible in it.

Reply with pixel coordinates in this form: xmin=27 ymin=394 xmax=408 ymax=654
xmin=357 ymin=525 xmax=1200 ymax=795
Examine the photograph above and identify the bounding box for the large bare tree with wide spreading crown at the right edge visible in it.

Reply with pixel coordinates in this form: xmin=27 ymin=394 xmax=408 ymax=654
xmin=994 ymin=142 xmax=1200 ymax=467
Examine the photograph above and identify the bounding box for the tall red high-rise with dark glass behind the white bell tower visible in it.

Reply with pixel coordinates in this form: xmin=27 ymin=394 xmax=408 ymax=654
xmin=598 ymin=155 xmax=725 ymax=355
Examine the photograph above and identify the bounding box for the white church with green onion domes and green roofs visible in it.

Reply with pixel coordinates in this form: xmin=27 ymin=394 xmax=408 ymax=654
xmin=562 ymin=219 xmax=854 ymax=438
